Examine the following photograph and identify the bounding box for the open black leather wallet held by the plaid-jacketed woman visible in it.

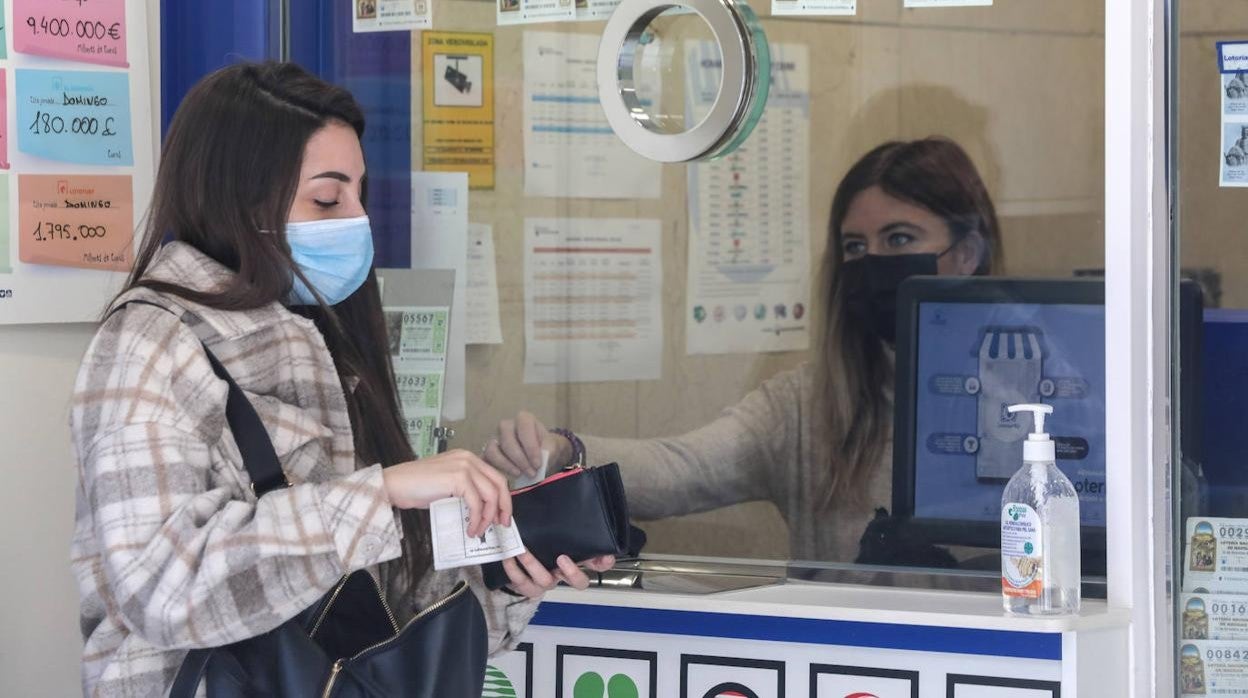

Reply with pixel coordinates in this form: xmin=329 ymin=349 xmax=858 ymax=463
xmin=482 ymin=463 xmax=641 ymax=589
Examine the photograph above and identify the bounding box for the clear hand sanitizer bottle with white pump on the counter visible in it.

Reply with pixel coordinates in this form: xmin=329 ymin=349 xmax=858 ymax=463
xmin=1001 ymin=405 xmax=1081 ymax=616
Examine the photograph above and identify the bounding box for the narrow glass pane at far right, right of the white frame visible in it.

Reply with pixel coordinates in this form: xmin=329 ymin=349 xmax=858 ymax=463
xmin=1169 ymin=0 xmax=1248 ymax=696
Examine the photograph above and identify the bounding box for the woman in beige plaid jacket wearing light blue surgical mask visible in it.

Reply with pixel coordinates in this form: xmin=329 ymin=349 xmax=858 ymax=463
xmin=71 ymin=64 xmax=612 ymax=696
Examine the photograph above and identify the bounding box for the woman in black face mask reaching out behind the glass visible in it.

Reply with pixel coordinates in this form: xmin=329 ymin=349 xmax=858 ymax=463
xmin=485 ymin=137 xmax=1001 ymax=564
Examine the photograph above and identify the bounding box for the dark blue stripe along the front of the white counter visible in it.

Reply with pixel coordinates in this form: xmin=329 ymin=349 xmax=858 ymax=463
xmin=533 ymin=602 xmax=1062 ymax=661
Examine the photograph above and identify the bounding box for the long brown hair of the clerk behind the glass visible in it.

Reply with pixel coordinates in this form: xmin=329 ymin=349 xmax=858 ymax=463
xmin=815 ymin=137 xmax=1001 ymax=507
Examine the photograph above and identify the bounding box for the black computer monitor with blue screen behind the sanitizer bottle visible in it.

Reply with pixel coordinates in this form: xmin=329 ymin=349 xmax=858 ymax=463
xmin=892 ymin=277 xmax=1106 ymax=574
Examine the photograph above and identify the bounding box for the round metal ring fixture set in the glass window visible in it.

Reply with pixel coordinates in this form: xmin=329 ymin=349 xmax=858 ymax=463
xmin=598 ymin=0 xmax=771 ymax=162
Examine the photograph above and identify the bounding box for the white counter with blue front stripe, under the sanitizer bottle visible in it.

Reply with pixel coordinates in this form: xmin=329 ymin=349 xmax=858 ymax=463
xmin=487 ymin=582 xmax=1129 ymax=698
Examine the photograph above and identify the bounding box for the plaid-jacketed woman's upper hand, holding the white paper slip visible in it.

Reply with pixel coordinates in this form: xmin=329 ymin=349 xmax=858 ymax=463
xmin=382 ymin=450 xmax=512 ymax=538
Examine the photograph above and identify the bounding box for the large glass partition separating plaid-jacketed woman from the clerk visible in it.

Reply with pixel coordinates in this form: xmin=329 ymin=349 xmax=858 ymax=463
xmin=291 ymin=0 xmax=1103 ymax=588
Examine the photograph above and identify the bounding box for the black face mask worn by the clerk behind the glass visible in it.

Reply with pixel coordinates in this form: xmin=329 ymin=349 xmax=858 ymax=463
xmin=841 ymin=255 xmax=940 ymax=345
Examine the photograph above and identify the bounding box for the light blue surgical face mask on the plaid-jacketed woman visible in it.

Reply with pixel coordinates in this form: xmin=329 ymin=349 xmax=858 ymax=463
xmin=286 ymin=216 xmax=373 ymax=306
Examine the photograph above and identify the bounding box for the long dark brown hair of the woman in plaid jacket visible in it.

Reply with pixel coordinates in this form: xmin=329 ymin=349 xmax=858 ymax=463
xmin=122 ymin=62 xmax=431 ymax=582
